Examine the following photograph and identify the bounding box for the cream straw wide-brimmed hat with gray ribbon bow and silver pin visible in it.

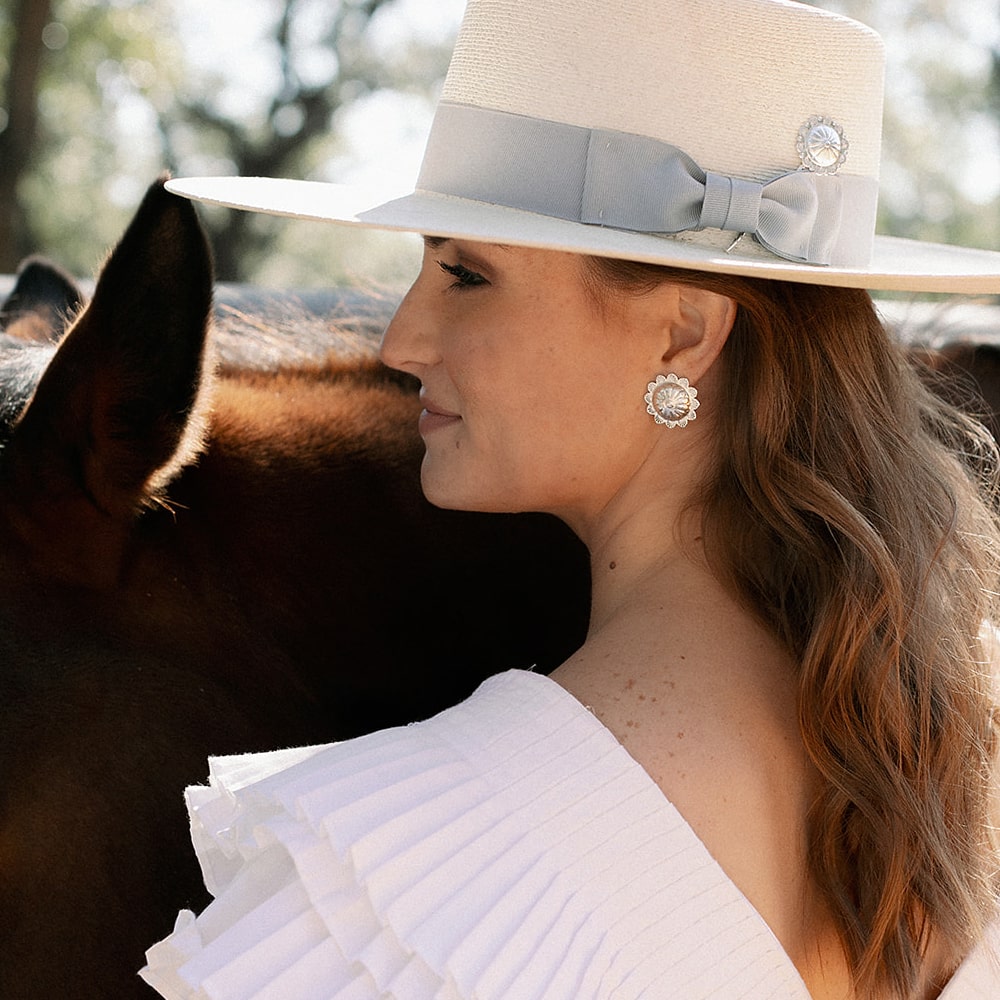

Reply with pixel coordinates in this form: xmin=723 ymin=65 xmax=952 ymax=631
xmin=167 ymin=0 xmax=1000 ymax=293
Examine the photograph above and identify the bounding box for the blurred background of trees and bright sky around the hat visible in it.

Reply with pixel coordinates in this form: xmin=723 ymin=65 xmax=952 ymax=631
xmin=0 ymin=0 xmax=1000 ymax=296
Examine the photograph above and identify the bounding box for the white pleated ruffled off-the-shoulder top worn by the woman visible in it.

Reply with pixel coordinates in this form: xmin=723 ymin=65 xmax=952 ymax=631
xmin=140 ymin=671 xmax=1000 ymax=1000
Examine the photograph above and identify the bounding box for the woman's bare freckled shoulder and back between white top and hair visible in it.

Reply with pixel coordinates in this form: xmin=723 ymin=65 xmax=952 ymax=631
xmin=557 ymin=627 xmax=849 ymax=981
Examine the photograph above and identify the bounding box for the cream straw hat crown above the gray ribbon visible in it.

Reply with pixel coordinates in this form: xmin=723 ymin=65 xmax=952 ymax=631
xmin=442 ymin=0 xmax=884 ymax=181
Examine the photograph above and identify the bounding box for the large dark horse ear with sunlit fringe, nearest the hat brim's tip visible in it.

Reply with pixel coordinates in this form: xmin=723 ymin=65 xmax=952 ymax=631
xmin=5 ymin=179 xmax=212 ymax=572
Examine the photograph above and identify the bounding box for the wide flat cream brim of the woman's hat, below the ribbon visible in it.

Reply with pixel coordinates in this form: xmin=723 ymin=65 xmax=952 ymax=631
xmin=167 ymin=177 xmax=1000 ymax=294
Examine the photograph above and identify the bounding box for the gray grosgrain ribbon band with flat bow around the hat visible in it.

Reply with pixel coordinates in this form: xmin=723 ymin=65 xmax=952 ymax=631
xmin=417 ymin=103 xmax=878 ymax=267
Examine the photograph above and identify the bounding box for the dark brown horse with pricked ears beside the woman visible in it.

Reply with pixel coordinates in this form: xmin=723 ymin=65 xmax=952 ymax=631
xmin=0 ymin=185 xmax=588 ymax=1000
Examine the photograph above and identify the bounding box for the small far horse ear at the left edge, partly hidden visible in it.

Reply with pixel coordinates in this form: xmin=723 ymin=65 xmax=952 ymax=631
xmin=0 ymin=256 xmax=83 ymax=342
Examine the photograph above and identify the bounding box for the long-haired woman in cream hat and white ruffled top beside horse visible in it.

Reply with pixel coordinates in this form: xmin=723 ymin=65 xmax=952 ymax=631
xmin=143 ymin=0 xmax=1000 ymax=1000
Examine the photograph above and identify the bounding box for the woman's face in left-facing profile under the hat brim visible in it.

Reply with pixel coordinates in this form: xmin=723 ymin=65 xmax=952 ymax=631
xmin=382 ymin=238 xmax=676 ymax=523
